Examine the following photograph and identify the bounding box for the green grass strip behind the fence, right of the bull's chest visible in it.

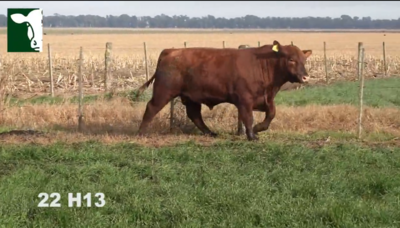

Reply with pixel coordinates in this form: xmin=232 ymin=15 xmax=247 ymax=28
xmin=275 ymin=77 xmax=400 ymax=107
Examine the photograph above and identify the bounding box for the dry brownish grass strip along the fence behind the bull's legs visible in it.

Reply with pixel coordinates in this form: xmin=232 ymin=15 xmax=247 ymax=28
xmin=0 ymin=98 xmax=400 ymax=145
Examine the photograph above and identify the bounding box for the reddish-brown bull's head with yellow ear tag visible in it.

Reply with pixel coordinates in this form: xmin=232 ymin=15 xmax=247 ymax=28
xmin=272 ymin=40 xmax=312 ymax=83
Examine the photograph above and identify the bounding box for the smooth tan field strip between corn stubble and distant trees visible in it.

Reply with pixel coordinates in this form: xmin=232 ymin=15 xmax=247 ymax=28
xmin=0 ymin=30 xmax=400 ymax=57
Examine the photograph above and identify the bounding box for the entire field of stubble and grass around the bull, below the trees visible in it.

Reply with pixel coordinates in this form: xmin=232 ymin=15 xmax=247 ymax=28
xmin=0 ymin=30 xmax=400 ymax=227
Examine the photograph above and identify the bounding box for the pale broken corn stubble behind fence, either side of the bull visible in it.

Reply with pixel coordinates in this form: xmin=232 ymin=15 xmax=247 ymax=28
xmin=2 ymin=42 xmax=400 ymax=94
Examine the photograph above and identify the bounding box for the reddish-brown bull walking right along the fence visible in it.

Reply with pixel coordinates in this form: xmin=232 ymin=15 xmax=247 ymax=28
xmin=137 ymin=40 xmax=312 ymax=141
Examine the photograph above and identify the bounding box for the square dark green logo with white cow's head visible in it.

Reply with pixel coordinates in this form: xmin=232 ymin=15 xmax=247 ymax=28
xmin=7 ymin=8 xmax=43 ymax=52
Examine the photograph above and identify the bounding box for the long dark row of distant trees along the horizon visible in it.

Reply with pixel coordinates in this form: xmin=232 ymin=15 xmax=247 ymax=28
xmin=0 ymin=14 xmax=400 ymax=29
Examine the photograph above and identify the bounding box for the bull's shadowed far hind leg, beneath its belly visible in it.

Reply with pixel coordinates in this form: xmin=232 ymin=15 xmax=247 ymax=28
xmin=182 ymin=98 xmax=217 ymax=137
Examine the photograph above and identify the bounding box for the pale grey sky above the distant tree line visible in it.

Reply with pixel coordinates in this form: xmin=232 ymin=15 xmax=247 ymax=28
xmin=0 ymin=1 xmax=400 ymax=19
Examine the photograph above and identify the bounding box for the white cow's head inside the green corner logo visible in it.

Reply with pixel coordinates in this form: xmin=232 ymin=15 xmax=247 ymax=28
xmin=11 ymin=9 xmax=42 ymax=51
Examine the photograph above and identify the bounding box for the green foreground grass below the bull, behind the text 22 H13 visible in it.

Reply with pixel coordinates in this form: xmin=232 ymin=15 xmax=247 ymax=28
xmin=0 ymin=142 xmax=400 ymax=228
